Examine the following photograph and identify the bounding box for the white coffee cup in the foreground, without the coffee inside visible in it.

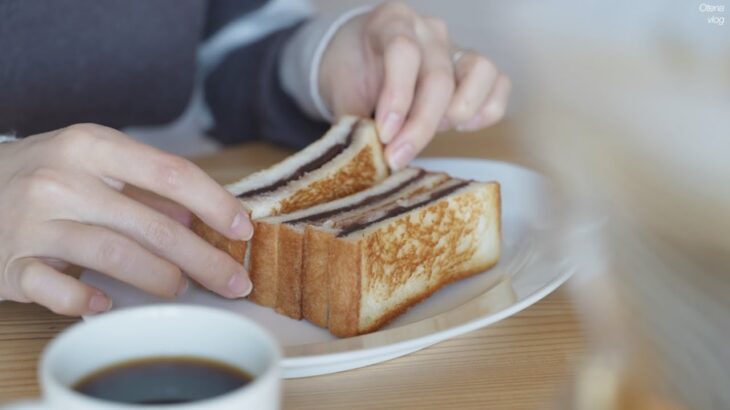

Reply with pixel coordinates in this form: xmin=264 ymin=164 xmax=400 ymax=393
xmin=3 ymin=305 xmax=281 ymax=410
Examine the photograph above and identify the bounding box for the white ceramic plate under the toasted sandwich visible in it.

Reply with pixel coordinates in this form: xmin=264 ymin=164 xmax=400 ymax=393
xmin=82 ymin=158 xmax=575 ymax=378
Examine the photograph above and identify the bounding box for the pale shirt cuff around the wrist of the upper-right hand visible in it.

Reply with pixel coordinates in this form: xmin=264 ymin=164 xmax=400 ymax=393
xmin=279 ymin=5 xmax=374 ymax=122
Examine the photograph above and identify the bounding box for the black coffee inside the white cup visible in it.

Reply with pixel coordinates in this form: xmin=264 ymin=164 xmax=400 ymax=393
xmin=73 ymin=357 xmax=251 ymax=405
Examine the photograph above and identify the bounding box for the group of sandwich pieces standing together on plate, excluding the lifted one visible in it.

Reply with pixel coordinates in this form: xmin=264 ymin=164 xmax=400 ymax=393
xmin=253 ymin=168 xmax=501 ymax=337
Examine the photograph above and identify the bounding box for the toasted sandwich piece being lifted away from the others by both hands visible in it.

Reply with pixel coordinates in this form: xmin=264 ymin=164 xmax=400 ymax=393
xmin=192 ymin=117 xmax=389 ymax=306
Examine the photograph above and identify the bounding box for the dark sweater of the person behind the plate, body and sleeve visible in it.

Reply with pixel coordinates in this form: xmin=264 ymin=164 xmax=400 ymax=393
xmin=0 ymin=0 xmax=326 ymax=147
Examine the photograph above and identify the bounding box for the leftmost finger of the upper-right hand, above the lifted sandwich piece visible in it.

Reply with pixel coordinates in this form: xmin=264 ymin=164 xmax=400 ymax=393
xmin=376 ymin=35 xmax=421 ymax=144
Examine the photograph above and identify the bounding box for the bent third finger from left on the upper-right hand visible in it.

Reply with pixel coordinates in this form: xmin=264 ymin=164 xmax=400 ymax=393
xmin=446 ymin=52 xmax=499 ymax=129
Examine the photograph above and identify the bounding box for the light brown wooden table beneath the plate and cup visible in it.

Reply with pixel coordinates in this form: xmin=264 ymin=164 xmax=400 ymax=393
xmin=0 ymin=121 xmax=586 ymax=410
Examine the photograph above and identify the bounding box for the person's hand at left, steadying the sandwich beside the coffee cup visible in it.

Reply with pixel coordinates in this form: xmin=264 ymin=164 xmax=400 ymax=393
xmin=0 ymin=124 xmax=253 ymax=315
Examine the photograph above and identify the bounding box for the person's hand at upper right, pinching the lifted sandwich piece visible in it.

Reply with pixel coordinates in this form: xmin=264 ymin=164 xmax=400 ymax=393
xmin=319 ymin=2 xmax=510 ymax=169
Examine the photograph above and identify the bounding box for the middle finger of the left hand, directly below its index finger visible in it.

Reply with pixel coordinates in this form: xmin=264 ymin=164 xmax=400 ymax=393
xmin=79 ymin=184 xmax=252 ymax=298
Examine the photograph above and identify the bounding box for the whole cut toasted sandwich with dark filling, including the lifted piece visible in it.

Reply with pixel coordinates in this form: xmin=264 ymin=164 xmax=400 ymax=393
xmin=193 ymin=117 xmax=501 ymax=337
